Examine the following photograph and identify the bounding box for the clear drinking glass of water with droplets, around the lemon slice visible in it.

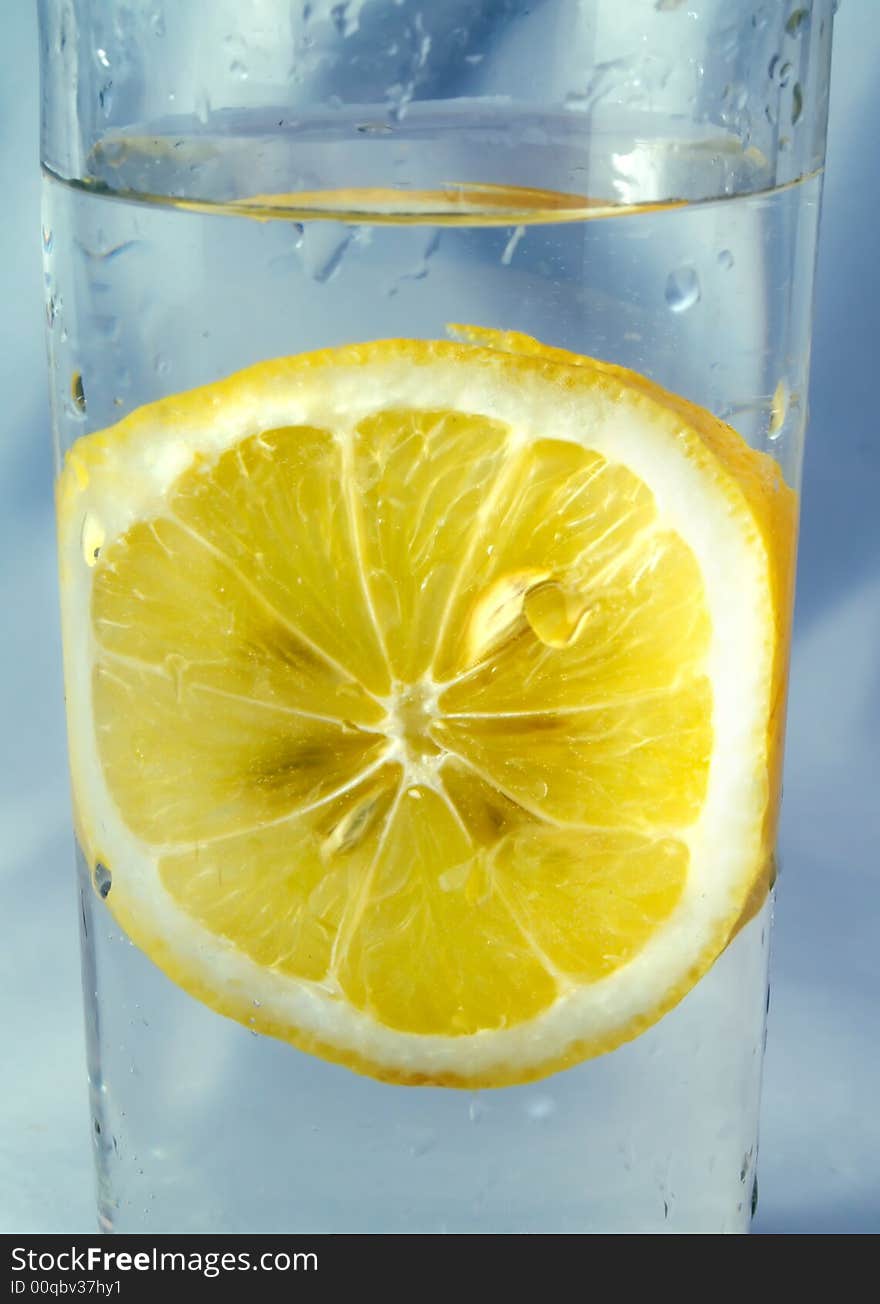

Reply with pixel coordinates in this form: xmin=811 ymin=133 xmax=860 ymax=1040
xmin=39 ymin=0 xmax=833 ymax=1234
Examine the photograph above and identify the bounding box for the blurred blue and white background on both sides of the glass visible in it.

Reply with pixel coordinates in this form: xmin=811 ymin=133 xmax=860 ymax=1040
xmin=0 ymin=0 xmax=880 ymax=1232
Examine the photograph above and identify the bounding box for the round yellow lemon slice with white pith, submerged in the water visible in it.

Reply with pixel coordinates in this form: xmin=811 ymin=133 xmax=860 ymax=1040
xmin=57 ymin=330 xmax=794 ymax=1086
